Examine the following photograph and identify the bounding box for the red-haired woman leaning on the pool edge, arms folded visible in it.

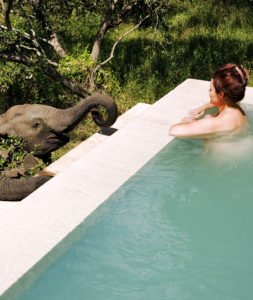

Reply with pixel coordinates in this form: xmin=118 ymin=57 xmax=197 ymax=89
xmin=169 ymin=64 xmax=248 ymax=138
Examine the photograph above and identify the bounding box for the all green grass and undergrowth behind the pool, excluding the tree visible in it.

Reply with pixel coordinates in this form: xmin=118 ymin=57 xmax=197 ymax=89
xmin=0 ymin=0 xmax=253 ymax=158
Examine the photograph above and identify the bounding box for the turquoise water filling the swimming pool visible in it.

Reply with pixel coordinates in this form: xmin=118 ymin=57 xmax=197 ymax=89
xmin=8 ymin=135 xmax=253 ymax=300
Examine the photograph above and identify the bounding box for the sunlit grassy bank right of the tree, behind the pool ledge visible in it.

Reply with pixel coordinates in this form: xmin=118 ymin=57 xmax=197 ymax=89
xmin=55 ymin=0 xmax=253 ymax=157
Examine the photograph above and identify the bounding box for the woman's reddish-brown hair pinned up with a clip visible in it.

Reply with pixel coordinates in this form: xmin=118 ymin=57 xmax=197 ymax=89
xmin=212 ymin=64 xmax=248 ymax=106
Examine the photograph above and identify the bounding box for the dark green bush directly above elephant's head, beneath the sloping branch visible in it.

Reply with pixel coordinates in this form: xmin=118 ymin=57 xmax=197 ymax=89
xmin=0 ymin=61 xmax=72 ymax=113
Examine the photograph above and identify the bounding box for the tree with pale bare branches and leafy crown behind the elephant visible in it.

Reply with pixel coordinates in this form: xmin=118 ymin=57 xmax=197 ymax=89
xmin=0 ymin=0 xmax=166 ymax=102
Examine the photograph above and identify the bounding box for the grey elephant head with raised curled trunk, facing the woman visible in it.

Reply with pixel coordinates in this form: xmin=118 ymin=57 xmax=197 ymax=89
xmin=0 ymin=94 xmax=118 ymax=157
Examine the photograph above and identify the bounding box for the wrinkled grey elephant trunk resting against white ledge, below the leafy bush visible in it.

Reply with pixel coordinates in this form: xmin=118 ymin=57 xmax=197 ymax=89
xmin=0 ymin=175 xmax=52 ymax=201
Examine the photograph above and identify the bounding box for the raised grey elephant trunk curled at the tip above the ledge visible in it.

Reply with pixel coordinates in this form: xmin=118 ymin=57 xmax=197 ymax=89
xmin=47 ymin=94 xmax=118 ymax=133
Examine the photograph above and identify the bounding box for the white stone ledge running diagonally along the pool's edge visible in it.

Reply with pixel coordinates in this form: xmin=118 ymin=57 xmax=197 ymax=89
xmin=0 ymin=79 xmax=253 ymax=299
